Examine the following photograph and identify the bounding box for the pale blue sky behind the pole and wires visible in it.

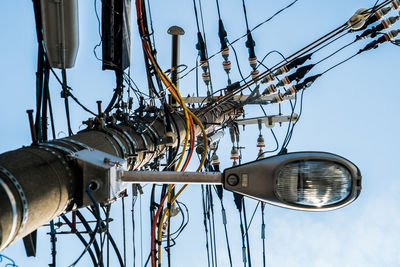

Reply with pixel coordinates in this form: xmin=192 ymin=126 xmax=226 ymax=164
xmin=0 ymin=0 xmax=400 ymax=266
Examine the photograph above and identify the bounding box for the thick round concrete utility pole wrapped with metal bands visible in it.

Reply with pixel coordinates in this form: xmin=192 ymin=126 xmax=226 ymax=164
xmin=0 ymin=102 xmax=241 ymax=250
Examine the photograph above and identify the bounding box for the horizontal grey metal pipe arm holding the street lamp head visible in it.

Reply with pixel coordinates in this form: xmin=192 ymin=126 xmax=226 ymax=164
xmin=120 ymin=171 xmax=222 ymax=185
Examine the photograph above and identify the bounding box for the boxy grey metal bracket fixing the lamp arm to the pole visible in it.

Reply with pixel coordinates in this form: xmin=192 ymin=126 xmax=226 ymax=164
xmin=71 ymin=149 xmax=127 ymax=206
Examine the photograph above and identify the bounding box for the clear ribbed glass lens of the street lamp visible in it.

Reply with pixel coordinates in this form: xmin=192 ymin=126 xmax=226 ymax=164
xmin=275 ymin=160 xmax=352 ymax=207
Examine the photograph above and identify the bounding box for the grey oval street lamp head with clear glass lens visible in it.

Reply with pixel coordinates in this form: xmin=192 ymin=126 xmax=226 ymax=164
xmin=223 ymin=152 xmax=361 ymax=211
